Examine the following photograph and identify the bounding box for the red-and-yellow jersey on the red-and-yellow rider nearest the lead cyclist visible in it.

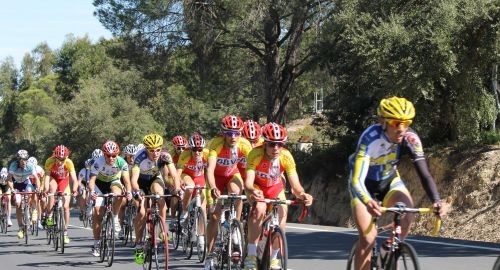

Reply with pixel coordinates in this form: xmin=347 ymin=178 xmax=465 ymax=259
xmin=247 ymin=146 xmax=297 ymax=198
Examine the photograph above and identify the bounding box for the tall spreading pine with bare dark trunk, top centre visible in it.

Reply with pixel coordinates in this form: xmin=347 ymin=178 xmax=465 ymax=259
xmin=94 ymin=0 xmax=333 ymax=122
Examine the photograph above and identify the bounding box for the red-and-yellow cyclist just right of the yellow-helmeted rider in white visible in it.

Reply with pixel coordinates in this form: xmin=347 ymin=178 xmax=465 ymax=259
xmin=177 ymin=133 xmax=208 ymax=224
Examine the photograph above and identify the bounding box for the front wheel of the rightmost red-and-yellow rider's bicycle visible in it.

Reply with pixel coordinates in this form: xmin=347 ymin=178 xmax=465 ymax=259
xmin=260 ymin=226 xmax=288 ymax=269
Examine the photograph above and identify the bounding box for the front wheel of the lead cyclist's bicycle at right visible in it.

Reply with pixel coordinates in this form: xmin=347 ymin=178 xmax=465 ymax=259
xmin=384 ymin=242 xmax=420 ymax=270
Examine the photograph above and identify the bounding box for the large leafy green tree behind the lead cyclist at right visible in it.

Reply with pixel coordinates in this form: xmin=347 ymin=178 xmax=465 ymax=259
xmin=320 ymin=0 xmax=499 ymax=142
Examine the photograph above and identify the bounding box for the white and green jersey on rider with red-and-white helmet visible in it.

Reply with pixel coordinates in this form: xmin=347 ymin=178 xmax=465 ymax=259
xmin=90 ymin=156 xmax=128 ymax=183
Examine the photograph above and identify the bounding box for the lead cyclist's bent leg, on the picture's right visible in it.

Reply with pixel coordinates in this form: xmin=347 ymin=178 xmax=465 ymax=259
xmin=383 ymin=177 xmax=414 ymax=239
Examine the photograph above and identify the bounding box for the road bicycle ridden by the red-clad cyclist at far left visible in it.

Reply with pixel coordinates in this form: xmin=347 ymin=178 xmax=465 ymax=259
xmin=45 ymin=192 xmax=69 ymax=254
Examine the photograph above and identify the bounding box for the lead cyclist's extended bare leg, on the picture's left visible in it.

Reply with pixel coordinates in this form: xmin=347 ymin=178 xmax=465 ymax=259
xmin=351 ymin=198 xmax=377 ymax=270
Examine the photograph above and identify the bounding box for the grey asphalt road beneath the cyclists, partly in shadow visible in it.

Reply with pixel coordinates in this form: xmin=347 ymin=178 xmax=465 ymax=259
xmin=0 ymin=213 xmax=500 ymax=270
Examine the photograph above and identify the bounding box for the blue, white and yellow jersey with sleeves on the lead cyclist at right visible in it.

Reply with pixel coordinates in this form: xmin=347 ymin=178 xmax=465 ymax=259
xmin=349 ymin=124 xmax=439 ymax=204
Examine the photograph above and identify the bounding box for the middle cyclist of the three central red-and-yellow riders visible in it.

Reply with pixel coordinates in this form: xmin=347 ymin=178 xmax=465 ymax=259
xmin=205 ymin=115 xmax=252 ymax=269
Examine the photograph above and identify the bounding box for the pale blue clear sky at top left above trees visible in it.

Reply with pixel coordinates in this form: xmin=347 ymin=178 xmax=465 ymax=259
xmin=0 ymin=0 xmax=112 ymax=68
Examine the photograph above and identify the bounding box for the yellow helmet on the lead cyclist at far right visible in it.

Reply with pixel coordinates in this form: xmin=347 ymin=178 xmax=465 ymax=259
xmin=377 ymin=97 xmax=415 ymax=120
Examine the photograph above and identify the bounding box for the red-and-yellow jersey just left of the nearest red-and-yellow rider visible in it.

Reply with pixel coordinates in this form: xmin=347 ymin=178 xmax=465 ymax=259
xmin=208 ymin=135 xmax=252 ymax=177
